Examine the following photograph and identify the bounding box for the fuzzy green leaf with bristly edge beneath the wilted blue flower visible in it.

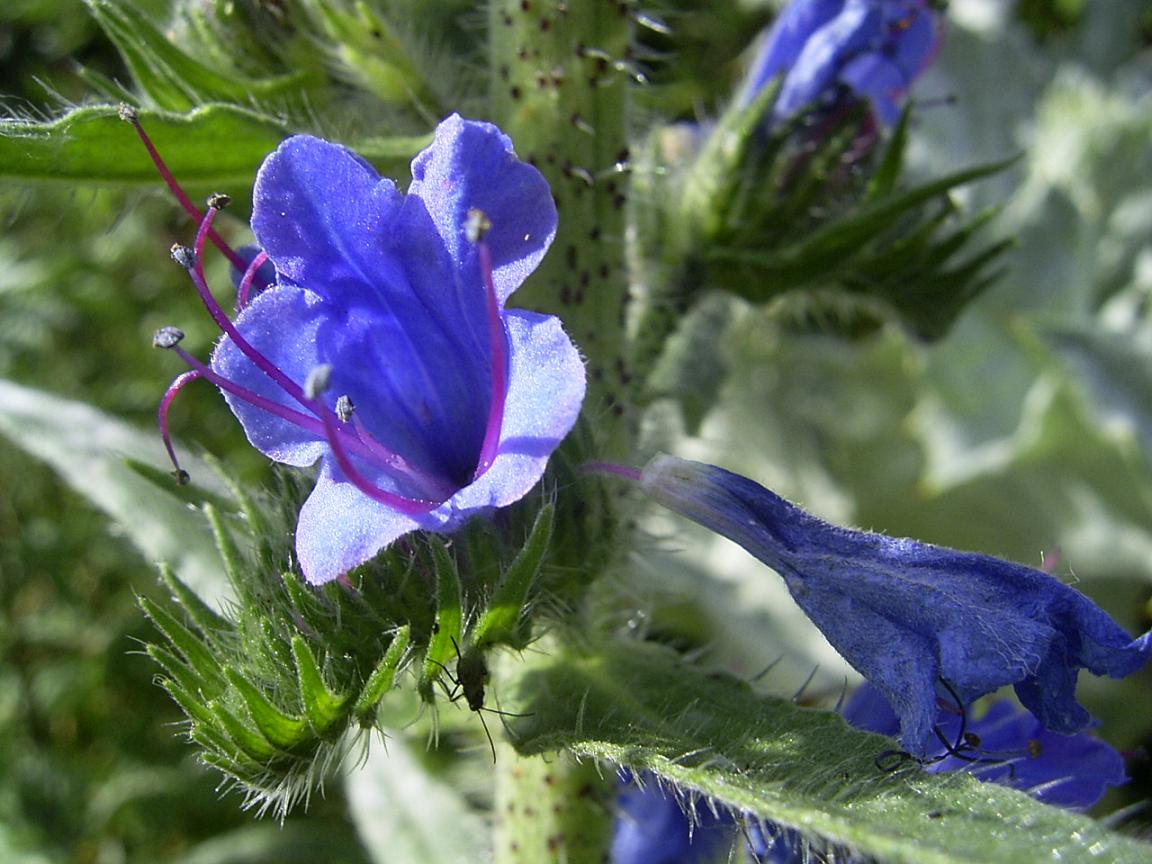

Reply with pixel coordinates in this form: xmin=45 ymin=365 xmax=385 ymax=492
xmin=501 ymin=643 xmax=1152 ymax=864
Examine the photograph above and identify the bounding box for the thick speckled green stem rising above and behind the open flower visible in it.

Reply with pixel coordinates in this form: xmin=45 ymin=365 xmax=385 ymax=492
xmin=488 ymin=0 xmax=632 ymax=458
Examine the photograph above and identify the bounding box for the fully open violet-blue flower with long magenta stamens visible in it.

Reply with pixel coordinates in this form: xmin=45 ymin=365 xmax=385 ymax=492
xmin=161 ymin=115 xmax=585 ymax=583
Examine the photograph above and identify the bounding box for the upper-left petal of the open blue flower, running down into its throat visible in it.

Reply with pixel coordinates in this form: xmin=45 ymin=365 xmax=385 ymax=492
xmin=245 ymin=132 xmax=497 ymax=484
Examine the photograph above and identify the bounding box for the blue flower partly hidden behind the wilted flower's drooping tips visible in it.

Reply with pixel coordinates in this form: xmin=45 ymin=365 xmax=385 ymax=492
xmin=843 ymin=683 xmax=1128 ymax=810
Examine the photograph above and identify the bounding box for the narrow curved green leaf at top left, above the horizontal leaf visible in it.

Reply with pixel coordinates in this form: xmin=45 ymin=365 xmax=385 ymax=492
xmin=85 ymin=0 xmax=316 ymax=111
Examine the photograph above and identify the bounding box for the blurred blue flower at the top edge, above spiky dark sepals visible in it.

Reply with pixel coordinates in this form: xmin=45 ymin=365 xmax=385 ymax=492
xmin=741 ymin=0 xmax=939 ymax=126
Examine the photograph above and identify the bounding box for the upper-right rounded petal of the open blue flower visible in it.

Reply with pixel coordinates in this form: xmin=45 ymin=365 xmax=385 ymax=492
xmin=408 ymin=114 xmax=556 ymax=303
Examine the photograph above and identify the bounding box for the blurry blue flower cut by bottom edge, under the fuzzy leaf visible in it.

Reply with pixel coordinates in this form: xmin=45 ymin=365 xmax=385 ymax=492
xmin=612 ymin=775 xmax=735 ymax=864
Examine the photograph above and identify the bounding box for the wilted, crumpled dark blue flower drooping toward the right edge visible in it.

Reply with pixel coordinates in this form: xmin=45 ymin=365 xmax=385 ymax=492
xmin=641 ymin=456 xmax=1152 ymax=757
